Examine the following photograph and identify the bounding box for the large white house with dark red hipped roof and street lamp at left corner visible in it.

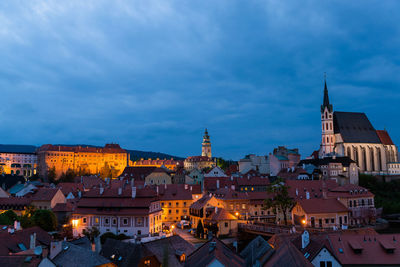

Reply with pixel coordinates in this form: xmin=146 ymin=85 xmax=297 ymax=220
xmin=71 ymin=184 xmax=162 ymax=237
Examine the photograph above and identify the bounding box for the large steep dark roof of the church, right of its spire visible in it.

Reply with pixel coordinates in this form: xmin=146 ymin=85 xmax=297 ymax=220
xmin=333 ymin=111 xmax=381 ymax=144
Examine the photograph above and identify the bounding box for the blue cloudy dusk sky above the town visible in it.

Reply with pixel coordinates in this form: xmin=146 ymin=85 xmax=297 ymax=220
xmin=0 ymin=0 xmax=400 ymax=159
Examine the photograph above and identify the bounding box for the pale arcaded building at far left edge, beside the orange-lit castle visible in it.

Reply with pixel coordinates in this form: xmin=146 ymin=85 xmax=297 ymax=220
xmin=0 ymin=152 xmax=37 ymax=177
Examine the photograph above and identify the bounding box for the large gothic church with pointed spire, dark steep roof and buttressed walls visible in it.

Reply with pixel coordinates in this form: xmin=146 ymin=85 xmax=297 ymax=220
xmin=319 ymin=81 xmax=398 ymax=174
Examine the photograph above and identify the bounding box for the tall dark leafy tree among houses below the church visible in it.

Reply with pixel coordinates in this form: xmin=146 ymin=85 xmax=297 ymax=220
xmin=264 ymin=179 xmax=295 ymax=225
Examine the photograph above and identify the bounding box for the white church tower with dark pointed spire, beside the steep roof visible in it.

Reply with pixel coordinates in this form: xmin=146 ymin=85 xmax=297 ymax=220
xmin=319 ymin=79 xmax=335 ymax=158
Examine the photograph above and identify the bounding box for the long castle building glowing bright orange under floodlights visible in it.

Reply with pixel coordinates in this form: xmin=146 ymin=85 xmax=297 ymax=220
xmin=37 ymin=144 xmax=129 ymax=180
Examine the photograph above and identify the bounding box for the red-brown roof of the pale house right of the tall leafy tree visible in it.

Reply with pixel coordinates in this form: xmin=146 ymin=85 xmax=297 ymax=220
xmin=297 ymin=198 xmax=349 ymax=214
